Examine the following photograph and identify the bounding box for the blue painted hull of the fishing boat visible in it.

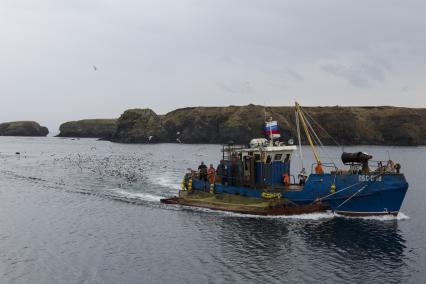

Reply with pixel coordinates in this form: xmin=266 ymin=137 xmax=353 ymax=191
xmin=193 ymin=174 xmax=408 ymax=215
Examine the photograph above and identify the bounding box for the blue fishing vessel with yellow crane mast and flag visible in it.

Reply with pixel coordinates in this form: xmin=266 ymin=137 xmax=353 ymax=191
xmin=161 ymin=103 xmax=408 ymax=216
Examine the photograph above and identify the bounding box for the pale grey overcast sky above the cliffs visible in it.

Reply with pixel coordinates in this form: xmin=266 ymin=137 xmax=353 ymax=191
xmin=0 ymin=0 xmax=426 ymax=132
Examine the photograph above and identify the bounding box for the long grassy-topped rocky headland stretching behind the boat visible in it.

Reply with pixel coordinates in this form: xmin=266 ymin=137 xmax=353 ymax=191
xmin=111 ymin=105 xmax=426 ymax=145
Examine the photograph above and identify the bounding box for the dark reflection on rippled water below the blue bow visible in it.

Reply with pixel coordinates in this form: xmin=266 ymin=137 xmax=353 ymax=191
xmin=298 ymin=218 xmax=407 ymax=281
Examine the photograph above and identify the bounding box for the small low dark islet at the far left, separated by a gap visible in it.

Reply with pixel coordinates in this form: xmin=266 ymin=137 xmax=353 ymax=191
xmin=0 ymin=121 xmax=49 ymax=136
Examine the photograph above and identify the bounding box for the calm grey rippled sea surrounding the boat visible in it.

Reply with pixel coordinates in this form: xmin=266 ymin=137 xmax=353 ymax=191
xmin=0 ymin=137 xmax=426 ymax=283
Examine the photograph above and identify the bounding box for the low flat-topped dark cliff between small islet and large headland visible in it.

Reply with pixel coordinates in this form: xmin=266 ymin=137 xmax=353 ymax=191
xmin=58 ymin=119 xmax=117 ymax=139
